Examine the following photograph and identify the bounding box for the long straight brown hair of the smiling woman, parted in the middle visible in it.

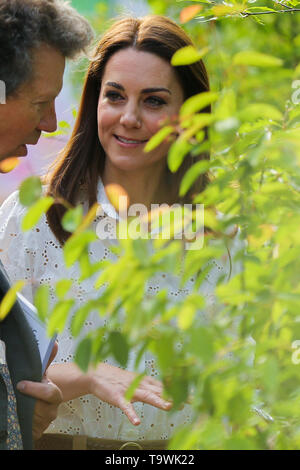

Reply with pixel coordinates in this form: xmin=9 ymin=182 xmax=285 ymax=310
xmin=47 ymin=15 xmax=210 ymax=244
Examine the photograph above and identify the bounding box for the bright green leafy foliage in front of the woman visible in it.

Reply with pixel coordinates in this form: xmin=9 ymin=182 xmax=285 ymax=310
xmin=1 ymin=0 xmax=300 ymax=449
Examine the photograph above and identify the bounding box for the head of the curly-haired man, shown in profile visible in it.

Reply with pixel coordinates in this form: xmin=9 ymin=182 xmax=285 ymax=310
xmin=0 ymin=0 xmax=92 ymax=158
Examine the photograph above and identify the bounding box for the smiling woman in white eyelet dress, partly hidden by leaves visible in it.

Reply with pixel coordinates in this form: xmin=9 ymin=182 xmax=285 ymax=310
xmin=0 ymin=16 xmax=234 ymax=449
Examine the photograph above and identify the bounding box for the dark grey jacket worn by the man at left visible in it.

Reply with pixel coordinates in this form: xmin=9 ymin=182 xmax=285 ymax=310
xmin=0 ymin=267 xmax=42 ymax=450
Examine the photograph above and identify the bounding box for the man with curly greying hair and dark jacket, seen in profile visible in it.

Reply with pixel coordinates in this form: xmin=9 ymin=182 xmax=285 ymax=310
xmin=0 ymin=0 xmax=92 ymax=449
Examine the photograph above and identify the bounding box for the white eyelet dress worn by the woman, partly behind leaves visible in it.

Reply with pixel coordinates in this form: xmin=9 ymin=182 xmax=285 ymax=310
xmin=0 ymin=180 xmax=239 ymax=441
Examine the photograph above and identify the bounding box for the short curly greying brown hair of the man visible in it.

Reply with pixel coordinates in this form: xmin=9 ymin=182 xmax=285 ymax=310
xmin=0 ymin=0 xmax=93 ymax=96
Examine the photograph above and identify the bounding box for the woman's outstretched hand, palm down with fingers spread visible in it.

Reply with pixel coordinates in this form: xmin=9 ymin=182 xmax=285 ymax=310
xmin=88 ymin=363 xmax=172 ymax=426
